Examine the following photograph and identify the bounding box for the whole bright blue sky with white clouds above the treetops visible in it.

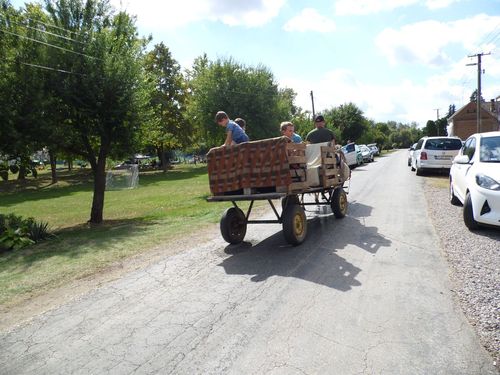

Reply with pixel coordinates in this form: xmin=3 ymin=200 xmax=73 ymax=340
xmin=12 ymin=0 xmax=500 ymax=127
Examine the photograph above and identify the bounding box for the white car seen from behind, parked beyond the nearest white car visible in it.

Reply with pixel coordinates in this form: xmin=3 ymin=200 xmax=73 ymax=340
xmin=411 ymin=137 xmax=462 ymax=176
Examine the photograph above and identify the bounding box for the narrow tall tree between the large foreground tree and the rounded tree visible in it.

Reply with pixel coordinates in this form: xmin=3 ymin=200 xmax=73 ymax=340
xmin=141 ymin=43 xmax=192 ymax=172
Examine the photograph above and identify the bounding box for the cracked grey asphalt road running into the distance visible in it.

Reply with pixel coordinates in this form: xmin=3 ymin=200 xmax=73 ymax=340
xmin=0 ymin=151 xmax=497 ymax=375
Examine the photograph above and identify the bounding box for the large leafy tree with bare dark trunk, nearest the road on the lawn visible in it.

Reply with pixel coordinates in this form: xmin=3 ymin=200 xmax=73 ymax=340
xmin=46 ymin=0 xmax=148 ymax=224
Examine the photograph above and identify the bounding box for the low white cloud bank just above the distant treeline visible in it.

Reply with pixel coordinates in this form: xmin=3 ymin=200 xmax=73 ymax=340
xmin=280 ymin=65 xmax=500 ymax=126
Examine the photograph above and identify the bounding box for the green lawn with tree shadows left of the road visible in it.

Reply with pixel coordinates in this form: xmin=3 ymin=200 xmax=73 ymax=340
xmin=0 ymin=165 xmax=249 ymax=306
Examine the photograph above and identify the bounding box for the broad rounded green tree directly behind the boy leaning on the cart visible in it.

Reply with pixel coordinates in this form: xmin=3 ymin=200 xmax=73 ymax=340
xmin=187 ymin=56 xmax=293 ymax=146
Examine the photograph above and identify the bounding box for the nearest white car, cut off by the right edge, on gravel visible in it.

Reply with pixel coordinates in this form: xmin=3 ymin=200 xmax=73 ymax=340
xmin=450 ymin=131 xmax=500 ymax=229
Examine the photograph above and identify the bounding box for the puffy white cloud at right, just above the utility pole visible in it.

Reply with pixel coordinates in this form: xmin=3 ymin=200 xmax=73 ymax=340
xmin=375 ymin=14 xmax=500 ymax=66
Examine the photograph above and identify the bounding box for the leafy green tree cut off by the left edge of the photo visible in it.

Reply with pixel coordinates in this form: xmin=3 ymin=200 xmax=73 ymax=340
xmin=0 ymin=2 xmax=48 ymax=180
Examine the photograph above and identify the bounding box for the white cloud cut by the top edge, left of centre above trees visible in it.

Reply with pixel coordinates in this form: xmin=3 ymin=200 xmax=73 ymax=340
xmin=111 ymin=0 xmax=286 ymax=29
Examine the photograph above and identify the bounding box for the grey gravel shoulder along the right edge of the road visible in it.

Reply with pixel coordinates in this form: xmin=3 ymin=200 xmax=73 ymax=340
xmin=424 ymin=176 xmax=500 ymax=370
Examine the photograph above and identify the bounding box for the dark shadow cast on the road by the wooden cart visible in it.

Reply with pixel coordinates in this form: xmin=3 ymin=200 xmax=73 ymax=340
xmin=219 ymin=203 xmax=391 ymax=291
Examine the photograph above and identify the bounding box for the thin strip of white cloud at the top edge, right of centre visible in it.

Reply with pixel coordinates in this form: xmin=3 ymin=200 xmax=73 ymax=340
xmin=335 ymin=0 xmax=461 ymax=16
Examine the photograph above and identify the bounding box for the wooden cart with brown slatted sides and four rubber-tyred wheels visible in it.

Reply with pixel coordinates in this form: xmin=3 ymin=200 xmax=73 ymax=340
xmin=207 ymin=137 xmax=350 ymax=245
